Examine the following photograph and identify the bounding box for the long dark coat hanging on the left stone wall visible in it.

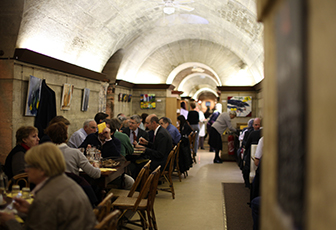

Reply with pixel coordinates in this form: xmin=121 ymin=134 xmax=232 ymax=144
xmin=34 ymin=79 xmax=56 ymax=139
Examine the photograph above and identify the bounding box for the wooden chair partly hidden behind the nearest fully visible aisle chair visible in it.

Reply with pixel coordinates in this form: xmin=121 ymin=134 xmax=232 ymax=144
xmin=109 ymin=160 xmax=151 ymax=197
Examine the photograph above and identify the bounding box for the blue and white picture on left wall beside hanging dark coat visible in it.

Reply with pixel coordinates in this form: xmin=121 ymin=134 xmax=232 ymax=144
xmin=25 ymin=76 xmax=42 ymax=117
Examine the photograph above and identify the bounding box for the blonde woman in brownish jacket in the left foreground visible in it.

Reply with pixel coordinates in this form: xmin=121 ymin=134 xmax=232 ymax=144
xmin=0 ymin=143 xmax=96 ymax=230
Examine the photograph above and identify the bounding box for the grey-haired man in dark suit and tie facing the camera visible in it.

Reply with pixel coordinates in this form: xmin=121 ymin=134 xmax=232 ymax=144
xmin=123 ymin=115 xmax=149 ymax=146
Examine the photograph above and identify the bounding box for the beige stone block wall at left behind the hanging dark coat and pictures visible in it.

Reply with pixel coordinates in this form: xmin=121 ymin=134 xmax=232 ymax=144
xmin=0 ymin=60 xmax=100 ymax=164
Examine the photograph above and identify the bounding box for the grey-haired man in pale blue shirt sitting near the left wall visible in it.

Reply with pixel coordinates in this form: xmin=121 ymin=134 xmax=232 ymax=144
xmin=68 ymin=119 xmax=97 ymax=148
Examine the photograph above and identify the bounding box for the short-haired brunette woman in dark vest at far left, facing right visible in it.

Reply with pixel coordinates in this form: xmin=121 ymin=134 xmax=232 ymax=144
xmin=5 ymin=126 xmax=40 ymax=179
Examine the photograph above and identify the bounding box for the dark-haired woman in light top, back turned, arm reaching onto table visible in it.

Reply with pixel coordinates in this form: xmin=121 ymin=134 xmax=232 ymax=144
xmin=45 ymin=122 xmax=101 ymax=178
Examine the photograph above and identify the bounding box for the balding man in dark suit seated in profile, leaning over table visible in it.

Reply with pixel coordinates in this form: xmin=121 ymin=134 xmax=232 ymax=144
xmin=137 ymin=114 xmax=173 ymax=170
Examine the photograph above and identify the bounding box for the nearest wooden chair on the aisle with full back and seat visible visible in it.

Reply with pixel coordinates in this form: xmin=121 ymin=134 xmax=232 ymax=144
xmin=112 ymin=166 xmax=161 ymax=229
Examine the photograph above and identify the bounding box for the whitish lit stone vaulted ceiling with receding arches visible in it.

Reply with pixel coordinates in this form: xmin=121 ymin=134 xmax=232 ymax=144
xmin=4 ymin=0 xmax=263 ymax=97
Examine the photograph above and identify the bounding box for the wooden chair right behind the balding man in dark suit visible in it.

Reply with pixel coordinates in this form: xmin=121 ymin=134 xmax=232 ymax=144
xmin=158 ymin=146 xmax=177 ymax=199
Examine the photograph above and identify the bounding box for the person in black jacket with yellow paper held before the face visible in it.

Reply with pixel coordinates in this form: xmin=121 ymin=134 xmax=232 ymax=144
xmin=79 ymin=122 xmax=121 ymax=158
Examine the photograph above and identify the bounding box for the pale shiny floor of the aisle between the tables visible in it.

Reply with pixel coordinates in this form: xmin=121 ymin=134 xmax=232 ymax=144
xmin=129 ymin=150 xmax=243 ymax=230
